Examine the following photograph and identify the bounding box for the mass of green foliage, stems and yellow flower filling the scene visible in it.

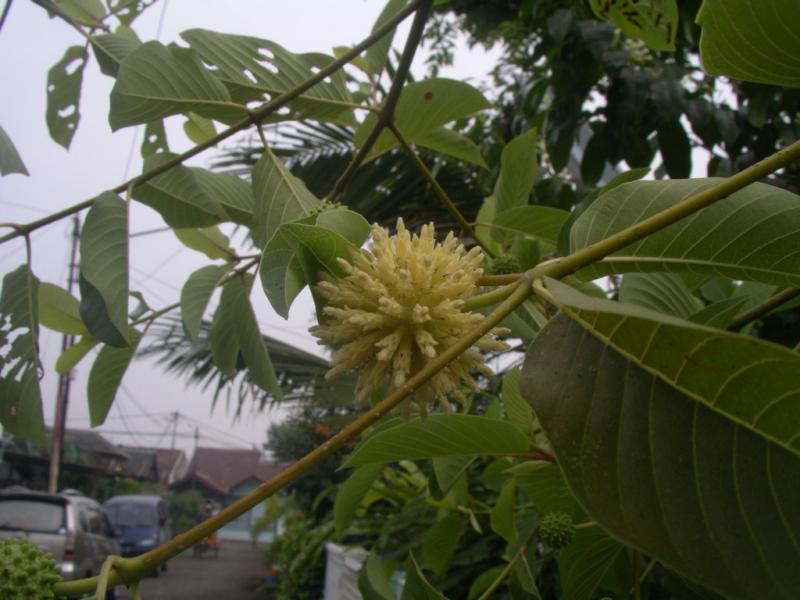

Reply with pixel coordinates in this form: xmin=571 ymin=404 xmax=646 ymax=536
xmin=0 ymin=0 xmax=800 ymax=600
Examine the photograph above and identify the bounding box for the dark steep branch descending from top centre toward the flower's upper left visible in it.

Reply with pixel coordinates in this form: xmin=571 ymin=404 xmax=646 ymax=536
xmin=326 ymin=0 xmax=433 ymax=202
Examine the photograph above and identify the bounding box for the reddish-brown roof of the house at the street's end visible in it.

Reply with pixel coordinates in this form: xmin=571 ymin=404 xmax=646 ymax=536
xmin=179 ymin=446 xmax=282 ymax=495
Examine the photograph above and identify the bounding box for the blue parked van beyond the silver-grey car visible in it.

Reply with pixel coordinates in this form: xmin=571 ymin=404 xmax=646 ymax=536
xmin=103 ymin=494 xmax=172 ymax=569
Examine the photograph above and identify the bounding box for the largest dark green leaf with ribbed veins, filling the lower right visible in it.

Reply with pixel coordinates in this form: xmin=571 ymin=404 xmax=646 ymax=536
xmin=521 ymin=282 xmax=800 ymax=599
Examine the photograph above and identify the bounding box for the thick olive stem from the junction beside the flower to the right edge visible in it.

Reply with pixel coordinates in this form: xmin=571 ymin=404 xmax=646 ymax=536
xmin=536 ymin=141 xmax=800 ymax=279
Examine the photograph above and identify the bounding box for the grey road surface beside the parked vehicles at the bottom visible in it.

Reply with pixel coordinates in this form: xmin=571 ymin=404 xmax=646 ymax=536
xmin=117 ymin=542 xmax=271 ymax=600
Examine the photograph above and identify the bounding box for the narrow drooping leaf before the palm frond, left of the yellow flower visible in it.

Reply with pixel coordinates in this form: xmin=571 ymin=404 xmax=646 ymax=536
xmin=225 ymin=278 xmax=283 ymax=401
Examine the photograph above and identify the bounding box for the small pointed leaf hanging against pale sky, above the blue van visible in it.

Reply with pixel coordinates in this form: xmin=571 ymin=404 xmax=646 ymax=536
xmin=86 ymin=328 xmax=141 ymax=427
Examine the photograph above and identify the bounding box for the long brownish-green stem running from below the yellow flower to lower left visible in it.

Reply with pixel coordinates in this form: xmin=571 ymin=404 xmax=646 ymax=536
xmin=54 ymin=277 xmax=531 ymax=596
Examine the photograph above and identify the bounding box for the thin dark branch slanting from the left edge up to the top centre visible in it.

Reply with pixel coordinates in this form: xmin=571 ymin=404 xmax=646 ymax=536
xmin=0 ymin=0 xmax=430 ymax=244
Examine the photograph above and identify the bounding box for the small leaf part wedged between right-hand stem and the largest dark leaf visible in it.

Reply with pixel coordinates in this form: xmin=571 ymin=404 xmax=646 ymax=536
xmin=619 ymin=273 xmax=703 ymax=319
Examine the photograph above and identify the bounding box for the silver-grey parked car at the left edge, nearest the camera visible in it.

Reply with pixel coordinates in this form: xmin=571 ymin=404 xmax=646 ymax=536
xmin=0 ymin=488 xmax=121 ymax=598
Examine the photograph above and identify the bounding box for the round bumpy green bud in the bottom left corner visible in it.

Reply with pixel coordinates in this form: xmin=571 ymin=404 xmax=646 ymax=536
xmin=0 ymin=540 xmax=61 ymax=600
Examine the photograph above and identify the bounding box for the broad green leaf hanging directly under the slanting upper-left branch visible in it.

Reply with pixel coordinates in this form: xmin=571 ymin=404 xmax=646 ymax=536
xmin=133 ymin=153 xmax=230 ymax=228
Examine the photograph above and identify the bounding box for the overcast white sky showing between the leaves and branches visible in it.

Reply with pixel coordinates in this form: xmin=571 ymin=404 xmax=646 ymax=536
xmin=0 ymin=0 xmax=496 ymax=450
